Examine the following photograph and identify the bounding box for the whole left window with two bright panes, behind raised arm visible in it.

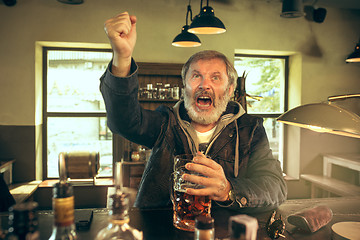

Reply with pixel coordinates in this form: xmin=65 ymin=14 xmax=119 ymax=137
xmin=43 ymin=47 xmax=113 ymax=178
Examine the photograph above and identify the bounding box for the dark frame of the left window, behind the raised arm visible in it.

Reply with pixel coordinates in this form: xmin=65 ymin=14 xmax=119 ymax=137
xmin=42 ymin=46 xmax=112 ymax=179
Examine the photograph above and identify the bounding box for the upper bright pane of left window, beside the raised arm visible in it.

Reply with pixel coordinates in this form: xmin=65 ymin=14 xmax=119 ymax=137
xmin=47 ymin=50 xmax=112 ymax=112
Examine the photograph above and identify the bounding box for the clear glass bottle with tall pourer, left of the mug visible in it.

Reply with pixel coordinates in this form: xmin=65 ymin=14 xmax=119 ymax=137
xmin=95 ymin=162 xmax=143 ymax=240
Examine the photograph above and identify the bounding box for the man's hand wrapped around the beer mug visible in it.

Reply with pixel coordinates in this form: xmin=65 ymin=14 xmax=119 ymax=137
xmin=183 ymin=152 xmax=231 ymax=201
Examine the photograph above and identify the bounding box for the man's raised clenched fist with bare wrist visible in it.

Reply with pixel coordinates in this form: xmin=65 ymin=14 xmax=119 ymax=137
xmin=104 ymin=12 xmax=136 ymax=77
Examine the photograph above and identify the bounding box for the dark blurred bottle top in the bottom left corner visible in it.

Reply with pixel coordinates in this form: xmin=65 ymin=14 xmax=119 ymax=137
xmin=5 ymin=202 xmax=40 ymax=240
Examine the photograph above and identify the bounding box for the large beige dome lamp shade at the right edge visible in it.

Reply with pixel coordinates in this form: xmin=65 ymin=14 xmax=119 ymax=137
xmin=277 ymin=103 xmax=360 ymax=138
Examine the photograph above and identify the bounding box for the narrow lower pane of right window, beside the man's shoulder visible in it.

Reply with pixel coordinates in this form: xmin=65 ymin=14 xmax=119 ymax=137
xmin=264 ymin=118 xmax=283 ymax=166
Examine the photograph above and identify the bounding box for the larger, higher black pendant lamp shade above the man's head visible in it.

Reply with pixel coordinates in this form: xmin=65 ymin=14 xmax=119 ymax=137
xmin=189 ymin=6 xmax=226 ymax=34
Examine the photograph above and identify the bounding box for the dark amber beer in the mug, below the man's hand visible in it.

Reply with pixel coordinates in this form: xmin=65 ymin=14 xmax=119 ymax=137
xmin=173 ymin=190 xmax=211 ymax=231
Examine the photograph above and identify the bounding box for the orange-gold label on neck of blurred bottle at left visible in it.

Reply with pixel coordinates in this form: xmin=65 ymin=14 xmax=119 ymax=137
xmin=53 ymin=196 xmax=75 ymax=227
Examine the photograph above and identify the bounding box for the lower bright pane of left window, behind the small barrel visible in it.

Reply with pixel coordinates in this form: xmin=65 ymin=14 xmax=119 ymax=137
xmin=47 ymin=117 xmax=112 ymax=177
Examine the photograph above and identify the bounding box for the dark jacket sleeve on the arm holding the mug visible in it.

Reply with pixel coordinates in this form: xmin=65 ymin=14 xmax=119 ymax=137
xmin=228 ymin=119 xmax=287 ymax=212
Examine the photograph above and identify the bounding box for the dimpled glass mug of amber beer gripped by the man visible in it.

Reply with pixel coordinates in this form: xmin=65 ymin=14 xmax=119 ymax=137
xmin=171 ymin=154 xmax=211 ymax=231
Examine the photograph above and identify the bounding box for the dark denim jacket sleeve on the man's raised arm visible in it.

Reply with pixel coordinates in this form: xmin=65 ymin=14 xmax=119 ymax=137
xmin=100 ymin=60 xmax=165 ymax=148
